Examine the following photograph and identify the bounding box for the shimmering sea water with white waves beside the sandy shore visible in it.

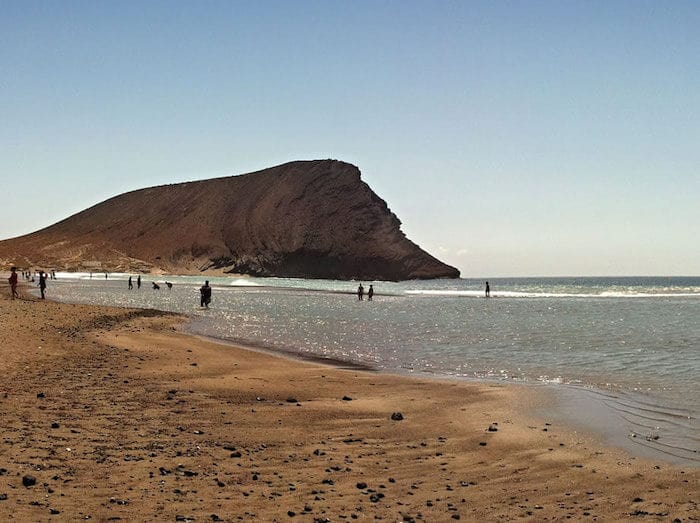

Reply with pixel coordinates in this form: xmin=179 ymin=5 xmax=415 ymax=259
xmin=39 ymin=273 xmax=700 ymax=464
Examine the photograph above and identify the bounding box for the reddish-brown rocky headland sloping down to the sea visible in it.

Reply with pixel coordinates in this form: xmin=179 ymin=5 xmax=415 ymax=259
xmin=0 ymin=160 xmax=459 ymax=280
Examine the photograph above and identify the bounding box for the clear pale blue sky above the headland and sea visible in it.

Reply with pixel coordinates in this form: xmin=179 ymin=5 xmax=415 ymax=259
xmin=0 ymin=0 xmax=700 ymax=277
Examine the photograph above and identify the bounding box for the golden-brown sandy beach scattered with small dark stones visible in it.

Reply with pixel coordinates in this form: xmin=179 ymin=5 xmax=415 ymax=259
xmin=0 ymin=280 xmax=700 ymax=522
